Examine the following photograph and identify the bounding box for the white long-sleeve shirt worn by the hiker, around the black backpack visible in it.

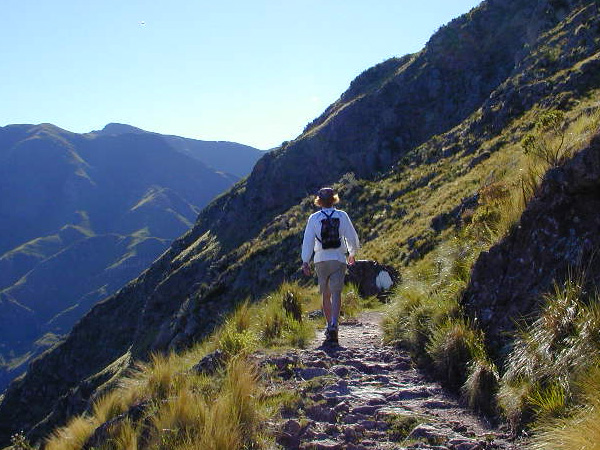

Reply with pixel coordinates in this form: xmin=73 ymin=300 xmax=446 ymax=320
xmin=302 ymin=208 xmax=360 ymax=263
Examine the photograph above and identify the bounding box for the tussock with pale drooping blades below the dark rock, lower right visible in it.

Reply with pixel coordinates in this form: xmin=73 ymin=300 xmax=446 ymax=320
xmin=499 ymin=273 xmax=600 ymax=427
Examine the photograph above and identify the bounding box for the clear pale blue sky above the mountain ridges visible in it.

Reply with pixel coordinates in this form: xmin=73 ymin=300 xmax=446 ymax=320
xmin=0 ymin=0 xmax=479 ymax=149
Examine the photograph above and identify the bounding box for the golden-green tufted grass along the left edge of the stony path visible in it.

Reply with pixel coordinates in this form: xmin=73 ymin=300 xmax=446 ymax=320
xmin=37 ymin=283 xmax=378 ymax=450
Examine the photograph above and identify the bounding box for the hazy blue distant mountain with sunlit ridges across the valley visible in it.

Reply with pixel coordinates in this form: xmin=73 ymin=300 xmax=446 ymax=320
xmin=0 ymin=124 xmax=258 ymax=390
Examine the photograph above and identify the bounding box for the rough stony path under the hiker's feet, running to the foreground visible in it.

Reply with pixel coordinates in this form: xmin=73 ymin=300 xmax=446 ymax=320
xmin=262 ymin=312 xmax=522 ymax=450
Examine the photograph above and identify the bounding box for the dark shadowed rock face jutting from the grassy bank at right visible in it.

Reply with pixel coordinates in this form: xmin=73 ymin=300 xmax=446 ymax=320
xmin=463 ymin=135 xmax=600 ymax=348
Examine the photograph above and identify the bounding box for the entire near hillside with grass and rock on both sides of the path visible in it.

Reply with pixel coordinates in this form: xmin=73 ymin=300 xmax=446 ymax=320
xmin=0 ymin=0 xmax=600 ymax=449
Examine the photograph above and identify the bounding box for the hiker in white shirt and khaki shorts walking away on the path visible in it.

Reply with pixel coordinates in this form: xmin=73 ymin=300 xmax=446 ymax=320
xmin=302 ymin=187 xmax=359 ymax=343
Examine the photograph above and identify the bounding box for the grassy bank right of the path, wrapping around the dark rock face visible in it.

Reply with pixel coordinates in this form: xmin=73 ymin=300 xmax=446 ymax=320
xmin=384 ymin=103 xmax=600 ymax=449
